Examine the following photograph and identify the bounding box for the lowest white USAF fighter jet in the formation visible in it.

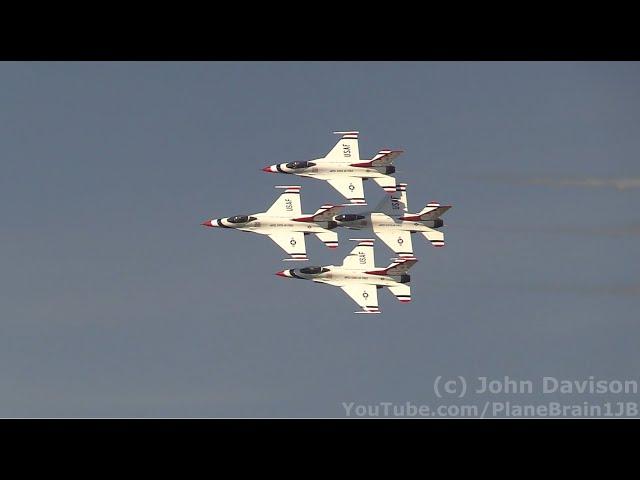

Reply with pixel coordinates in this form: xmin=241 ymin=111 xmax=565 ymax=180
xmin=276 ymin=238 xmax=417 ymax=313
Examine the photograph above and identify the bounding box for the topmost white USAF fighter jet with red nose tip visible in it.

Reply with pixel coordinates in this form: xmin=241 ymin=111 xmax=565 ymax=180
xmin=262 ymin=132 xmax=402 ymax=205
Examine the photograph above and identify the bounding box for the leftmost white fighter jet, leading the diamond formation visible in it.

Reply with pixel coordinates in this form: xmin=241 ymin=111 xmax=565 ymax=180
xmin=202 ymin=185 xmax=342 ymax=261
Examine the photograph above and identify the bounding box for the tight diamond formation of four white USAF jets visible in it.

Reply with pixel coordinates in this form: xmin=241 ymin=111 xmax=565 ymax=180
xmin=202 ymin=131 xmax=451 ymax=313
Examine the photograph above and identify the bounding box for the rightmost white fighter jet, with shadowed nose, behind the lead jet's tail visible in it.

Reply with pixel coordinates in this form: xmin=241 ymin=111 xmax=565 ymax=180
xmin=334 ymin=183 xmax=451 ymax=257
